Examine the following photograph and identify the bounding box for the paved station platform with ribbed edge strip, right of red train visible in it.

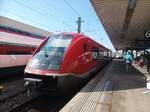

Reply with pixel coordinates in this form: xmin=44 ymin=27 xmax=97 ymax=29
xmin=60 ymin=60 xmax=150 ymax=112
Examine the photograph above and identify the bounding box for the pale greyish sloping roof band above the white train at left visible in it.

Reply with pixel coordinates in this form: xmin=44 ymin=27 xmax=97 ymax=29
xmin=0 ymin=16 xmax=52 ymax=36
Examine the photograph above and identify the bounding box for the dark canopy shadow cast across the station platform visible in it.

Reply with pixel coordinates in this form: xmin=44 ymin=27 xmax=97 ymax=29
xmin=82 ymin=60 xmax=146 ymax=92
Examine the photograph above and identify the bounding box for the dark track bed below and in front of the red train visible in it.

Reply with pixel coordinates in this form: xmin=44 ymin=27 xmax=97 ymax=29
xmin=0 ymin=66 xmax=105 ymax=112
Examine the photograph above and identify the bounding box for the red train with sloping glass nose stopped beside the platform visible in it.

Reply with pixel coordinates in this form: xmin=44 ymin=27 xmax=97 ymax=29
xmin=25 ymin=33 xmax=111 ymax=92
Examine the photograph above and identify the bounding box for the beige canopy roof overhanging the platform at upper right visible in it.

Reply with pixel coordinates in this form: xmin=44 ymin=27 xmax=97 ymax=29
xmin=91 ymin=0 xmax=150 ymax=49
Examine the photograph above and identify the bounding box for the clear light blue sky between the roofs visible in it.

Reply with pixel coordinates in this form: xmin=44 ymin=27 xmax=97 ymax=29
xmin=0 ymin=0 xmax=115 ymax=51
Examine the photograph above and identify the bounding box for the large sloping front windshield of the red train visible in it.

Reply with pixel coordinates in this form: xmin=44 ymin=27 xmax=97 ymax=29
xmin=28 ymin=35 xmax=73 ymax=70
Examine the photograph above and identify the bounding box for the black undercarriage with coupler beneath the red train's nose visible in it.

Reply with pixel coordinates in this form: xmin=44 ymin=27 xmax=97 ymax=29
xmin=24 ymin=74 xmax=86 ymax=94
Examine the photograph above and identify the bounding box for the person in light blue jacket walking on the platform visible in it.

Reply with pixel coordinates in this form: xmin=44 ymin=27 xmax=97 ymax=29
xmin=123 ymin=52 xmax=133 ymax=72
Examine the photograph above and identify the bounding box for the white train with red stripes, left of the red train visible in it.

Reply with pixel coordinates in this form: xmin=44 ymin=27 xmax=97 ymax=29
xmin=0 ymin=25 xmax=45 ymax=76
